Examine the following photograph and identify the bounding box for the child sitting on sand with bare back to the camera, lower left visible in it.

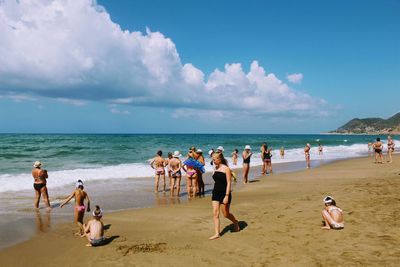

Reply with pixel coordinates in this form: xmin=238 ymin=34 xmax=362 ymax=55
xmin=84 ymin=206 xmax=106 ymax=247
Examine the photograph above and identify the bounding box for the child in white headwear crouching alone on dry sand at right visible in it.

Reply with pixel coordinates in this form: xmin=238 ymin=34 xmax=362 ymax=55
xmin=322 ymin=196 xmax=344 ymax=230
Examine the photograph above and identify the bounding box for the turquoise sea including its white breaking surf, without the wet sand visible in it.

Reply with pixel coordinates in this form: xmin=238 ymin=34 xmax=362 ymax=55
xmin=0 ymin=134 xmax=394 ymax=192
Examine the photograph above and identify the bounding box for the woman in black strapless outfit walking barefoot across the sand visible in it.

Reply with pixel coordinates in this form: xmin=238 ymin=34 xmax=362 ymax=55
xmin=208 ymin=152 xmax=240 ymax=240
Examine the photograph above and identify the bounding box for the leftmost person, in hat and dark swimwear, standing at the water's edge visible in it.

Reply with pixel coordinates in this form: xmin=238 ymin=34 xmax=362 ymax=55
xmin=32 ymin=161 xmax=51 ymax=209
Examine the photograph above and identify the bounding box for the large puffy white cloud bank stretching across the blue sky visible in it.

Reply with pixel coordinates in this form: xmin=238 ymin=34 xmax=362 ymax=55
xmin=0 ymin=0 xmax=326 ymax=117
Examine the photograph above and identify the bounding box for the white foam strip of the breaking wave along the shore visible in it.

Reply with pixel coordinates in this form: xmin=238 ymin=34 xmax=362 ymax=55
xmin=0 ymin=141 xmax=400 ymax=192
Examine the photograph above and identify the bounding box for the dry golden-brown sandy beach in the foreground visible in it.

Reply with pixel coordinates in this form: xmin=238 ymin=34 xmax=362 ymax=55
xmin=0 ymin=156 xmax=400 ymax=266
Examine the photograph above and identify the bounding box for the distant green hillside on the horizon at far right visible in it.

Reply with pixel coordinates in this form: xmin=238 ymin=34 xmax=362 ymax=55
xmin=330 ymin=112 xmax=400 ymax=134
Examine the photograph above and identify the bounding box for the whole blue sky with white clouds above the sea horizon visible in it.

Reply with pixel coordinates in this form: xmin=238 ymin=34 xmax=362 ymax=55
xmin=0 ymin=0 xmax=400 ymax=134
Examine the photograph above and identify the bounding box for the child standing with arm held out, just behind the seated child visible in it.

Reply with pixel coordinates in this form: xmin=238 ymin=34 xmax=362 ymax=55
xmin=60 ymin=180 xmax=90 ymax=235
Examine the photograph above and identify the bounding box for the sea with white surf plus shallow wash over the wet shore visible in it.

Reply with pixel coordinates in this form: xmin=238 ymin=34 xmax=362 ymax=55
xmin=0 ymin=134 xmax=400 ymax=249
